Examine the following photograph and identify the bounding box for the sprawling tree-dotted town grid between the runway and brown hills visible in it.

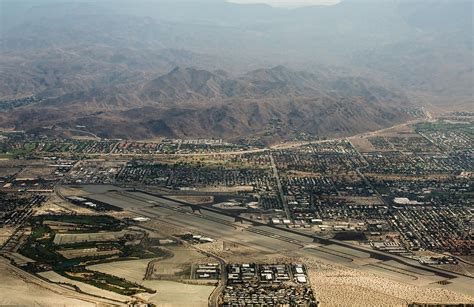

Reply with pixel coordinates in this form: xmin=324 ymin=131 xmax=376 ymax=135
xmin=0 ymin=123 xmax=474 ymax=260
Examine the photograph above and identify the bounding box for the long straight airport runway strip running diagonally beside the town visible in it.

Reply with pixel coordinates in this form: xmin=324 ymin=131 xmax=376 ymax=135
xmin=75 ymin=186 xmax=473 ymax=295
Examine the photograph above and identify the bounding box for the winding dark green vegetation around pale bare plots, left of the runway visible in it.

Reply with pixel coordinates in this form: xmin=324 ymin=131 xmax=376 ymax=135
xmin=20 ymin=215 xmax=172 ymax=295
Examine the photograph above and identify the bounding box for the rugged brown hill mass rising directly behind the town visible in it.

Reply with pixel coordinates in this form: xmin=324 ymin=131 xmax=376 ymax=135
xmin=0 ymin=66 xmax=410 ymax=141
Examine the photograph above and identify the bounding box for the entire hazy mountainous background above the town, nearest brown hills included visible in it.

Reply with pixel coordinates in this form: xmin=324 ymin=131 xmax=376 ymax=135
xmin=0 ymin=0 xmax=474 ymax=142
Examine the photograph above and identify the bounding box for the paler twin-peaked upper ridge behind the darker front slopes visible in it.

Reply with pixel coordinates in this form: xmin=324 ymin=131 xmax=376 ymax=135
xmin=141 ymin=65 xmax=408 ymax=103
